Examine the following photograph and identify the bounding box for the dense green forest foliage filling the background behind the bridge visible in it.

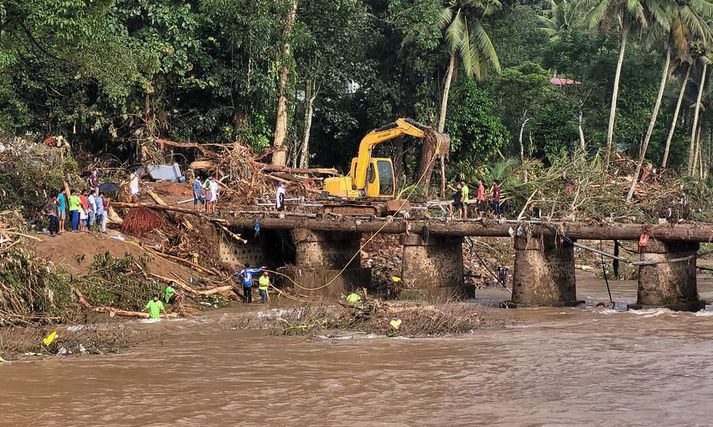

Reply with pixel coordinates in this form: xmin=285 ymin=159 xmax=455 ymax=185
xmin=0 ymin=0 xmax=713 ymax=180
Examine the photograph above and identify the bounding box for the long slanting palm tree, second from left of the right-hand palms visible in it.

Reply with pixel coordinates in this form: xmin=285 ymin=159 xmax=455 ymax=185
xmin=626 ymin=0 xmax=711 ymax=202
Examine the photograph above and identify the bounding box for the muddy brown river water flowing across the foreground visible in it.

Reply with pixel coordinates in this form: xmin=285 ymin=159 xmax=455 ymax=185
xmin=0 ymin=279 xmax=713 ymax=426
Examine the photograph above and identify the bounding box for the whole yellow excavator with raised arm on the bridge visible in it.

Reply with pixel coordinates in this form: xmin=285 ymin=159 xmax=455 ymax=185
xmin=323 ymin=118 xmax=450 ymax=214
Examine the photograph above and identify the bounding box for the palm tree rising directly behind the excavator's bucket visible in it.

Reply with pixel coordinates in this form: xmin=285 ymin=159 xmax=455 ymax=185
xmin=422 ymin=0 xmax=501 ymax=195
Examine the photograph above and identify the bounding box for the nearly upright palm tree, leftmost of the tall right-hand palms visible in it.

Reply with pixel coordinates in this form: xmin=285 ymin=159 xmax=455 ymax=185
xmin=584 ymin=0 xmax=650 ymax=169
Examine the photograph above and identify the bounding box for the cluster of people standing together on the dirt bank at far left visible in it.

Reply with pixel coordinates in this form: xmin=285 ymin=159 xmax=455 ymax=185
xmin=42 ymin=171 xmax=111 ymax=236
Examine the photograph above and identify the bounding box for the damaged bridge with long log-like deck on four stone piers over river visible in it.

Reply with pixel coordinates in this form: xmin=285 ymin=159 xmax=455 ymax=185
xmin=115 ymin=201 xmax=713 ymax=310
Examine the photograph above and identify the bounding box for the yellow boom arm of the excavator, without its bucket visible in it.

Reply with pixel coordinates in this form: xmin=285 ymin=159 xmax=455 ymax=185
xmin=352 ymin=119 xmax=430 ymax=190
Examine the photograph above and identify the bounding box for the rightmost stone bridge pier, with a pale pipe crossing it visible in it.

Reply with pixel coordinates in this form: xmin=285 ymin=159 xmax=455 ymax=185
xmin=631 ymin=239 xmax=705 ymax=311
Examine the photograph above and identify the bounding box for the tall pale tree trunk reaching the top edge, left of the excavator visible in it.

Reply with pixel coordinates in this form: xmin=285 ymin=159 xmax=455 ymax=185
xmin=272 ymin=0 xmax=297 ymax=166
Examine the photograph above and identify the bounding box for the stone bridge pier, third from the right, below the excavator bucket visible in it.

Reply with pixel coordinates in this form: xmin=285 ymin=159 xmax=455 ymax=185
xmin=401 ymin=234 xmax=474 ymax=300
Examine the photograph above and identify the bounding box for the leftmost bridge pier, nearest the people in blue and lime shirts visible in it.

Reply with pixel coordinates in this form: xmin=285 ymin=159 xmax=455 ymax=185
xmin=284 ymin=228 xmax=371 ymax=298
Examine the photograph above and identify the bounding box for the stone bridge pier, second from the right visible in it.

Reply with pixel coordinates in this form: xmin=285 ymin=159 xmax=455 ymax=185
xmin=508 ymin=236 xmax=579 ymax=307
